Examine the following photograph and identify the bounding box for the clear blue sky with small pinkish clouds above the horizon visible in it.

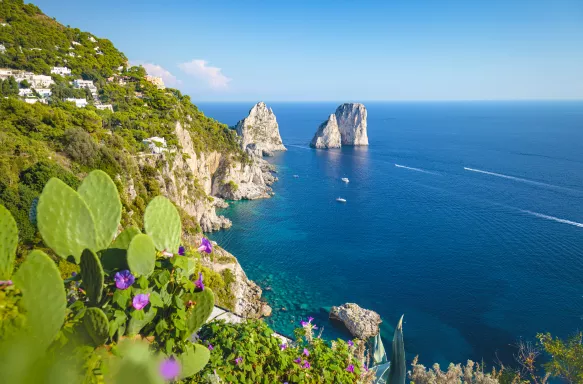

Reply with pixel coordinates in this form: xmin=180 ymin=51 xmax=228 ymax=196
xmin=33 ymin=0 xmax=583 ymax=101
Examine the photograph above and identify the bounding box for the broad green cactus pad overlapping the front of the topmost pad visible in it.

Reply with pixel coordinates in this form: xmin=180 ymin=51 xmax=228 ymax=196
xmin=37 ymin=178 xmax=97 ymax=263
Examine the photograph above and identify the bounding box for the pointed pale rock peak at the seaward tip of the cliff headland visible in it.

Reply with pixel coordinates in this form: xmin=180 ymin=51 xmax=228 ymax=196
xmin=235 ymin=101 xmax=286 ymax=156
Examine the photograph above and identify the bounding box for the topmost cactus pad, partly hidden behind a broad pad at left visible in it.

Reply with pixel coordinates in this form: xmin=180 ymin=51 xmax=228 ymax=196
xmin=77 ymin=170 xmax=121 ymax=249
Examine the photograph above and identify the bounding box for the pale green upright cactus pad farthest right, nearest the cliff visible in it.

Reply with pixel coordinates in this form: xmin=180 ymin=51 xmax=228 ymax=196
xmin=144 ymin=196 xmax=182 ymax=253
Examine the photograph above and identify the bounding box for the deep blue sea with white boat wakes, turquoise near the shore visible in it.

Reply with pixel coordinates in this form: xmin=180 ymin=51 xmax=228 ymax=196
xmin=199 ymin=102 xmax=583 ymax=364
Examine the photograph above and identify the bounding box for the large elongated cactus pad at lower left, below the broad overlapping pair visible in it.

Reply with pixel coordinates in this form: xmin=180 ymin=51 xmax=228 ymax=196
xmin=12 ymin=250 xmax=67 ymax=351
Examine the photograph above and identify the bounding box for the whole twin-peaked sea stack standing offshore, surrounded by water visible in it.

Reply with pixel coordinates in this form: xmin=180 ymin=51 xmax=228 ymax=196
xmin=310 ymin=103 xmax=368 ymax=148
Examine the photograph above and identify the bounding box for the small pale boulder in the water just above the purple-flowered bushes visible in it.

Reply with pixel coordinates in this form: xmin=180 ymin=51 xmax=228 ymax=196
xmin=330 ymin=303 xmax=382 ymax=340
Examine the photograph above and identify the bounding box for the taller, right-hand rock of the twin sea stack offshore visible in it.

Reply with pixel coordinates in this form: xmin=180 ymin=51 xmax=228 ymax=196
xmin=335 ymin=103 xmax=368 ymax=145
